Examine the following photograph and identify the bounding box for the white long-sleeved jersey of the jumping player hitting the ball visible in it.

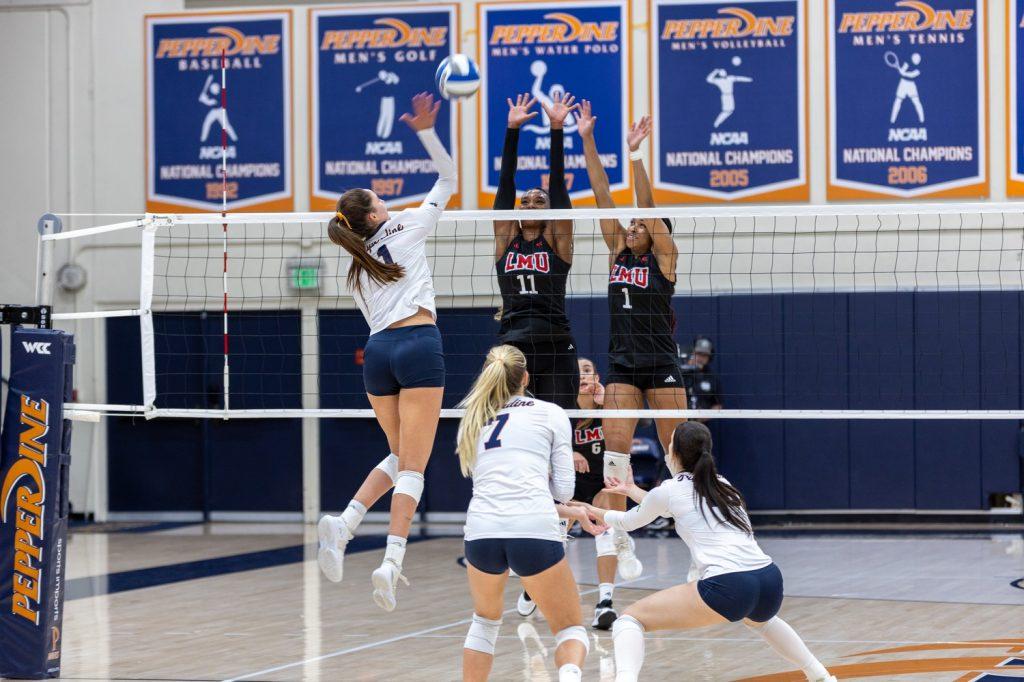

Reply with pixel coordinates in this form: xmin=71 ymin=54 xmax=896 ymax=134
xmin=352 ymin=128 xmax=459 ymax=335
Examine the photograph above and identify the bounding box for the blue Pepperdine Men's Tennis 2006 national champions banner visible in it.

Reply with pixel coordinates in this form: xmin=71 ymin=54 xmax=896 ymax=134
xmin=827 ymin=0 xmax=988 ymax=200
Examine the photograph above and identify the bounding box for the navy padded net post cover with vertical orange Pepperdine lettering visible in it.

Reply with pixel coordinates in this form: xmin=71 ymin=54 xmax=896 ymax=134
xmin=0 ymin=328 xmax=75 ymax=679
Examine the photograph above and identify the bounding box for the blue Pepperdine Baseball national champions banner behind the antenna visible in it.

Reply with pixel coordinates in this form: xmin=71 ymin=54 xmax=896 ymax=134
xmin=145 ymin=10 xmax=294 ymax=211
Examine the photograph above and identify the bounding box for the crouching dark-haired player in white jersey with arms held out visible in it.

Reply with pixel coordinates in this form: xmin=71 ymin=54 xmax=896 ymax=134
xmin=585 ymin=422 xmax=836 ymax=682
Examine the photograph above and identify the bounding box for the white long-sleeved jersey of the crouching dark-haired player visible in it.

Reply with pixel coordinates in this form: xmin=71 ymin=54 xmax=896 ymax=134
xmin=604 ymin=473 xmax=771 ymax=578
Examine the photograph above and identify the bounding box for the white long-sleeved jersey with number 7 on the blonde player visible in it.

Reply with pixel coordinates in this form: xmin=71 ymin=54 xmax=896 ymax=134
xmin=465 ymin=395 xmax=575 ymax=542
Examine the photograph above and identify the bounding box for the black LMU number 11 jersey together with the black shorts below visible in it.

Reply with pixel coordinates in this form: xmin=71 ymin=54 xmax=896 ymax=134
xmin=495 ymin=235 xmax=580 ymax=410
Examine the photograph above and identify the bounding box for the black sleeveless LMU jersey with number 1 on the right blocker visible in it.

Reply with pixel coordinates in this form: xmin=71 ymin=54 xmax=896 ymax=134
xmin=608 ymin=249 xmax=678 ymax=368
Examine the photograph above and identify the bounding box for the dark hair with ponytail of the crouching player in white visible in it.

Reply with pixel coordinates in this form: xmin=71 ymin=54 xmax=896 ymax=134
xmin=672 ymin=422 xmax=754 ymax=534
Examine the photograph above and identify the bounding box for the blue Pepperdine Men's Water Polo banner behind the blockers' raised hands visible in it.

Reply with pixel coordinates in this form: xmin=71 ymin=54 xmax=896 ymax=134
xmin=477 ymin=0 xmax=630 ymax=207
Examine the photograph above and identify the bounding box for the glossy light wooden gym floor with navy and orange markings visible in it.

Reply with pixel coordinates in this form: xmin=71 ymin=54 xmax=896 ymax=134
xmin=62 ymin=523 xmax=1024 ymax=682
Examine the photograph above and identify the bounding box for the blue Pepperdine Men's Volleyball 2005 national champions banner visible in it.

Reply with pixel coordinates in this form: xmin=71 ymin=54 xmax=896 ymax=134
xmin=651 ymin=0 xmax=808 ymax=202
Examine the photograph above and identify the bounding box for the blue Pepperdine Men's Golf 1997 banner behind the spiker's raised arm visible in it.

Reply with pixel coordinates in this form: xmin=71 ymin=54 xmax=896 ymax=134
xmin=309 ymin=4 xmax=460 ymax=211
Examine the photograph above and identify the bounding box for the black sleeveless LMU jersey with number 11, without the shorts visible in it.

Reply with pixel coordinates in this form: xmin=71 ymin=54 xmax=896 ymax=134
xmin=496 ymin=235 xmax=569 ymax=342
